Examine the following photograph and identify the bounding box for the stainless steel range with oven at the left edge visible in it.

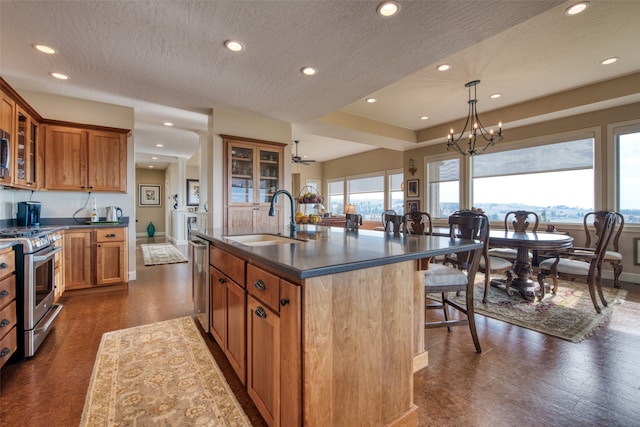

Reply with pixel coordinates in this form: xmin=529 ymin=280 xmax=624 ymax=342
xmin=0 ymin=227 xmax=62 ymax=357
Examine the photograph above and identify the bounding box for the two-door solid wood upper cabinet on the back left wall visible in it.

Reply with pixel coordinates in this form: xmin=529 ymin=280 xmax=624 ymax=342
xmin=45 ymin=124 xmax=128 ymax=192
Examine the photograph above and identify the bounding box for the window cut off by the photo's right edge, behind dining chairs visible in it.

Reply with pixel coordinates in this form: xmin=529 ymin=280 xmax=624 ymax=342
xmin=616 ymin=132 xmax=640 ymax=224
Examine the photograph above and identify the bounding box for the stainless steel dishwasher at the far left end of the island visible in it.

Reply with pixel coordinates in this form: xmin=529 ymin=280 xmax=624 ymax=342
xmin=189 ymin=235 xmax=209 ymax=333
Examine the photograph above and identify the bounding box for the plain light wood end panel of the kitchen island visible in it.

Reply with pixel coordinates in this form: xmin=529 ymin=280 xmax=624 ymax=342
xmin=302 ymin=261 xmax=417 ymax=426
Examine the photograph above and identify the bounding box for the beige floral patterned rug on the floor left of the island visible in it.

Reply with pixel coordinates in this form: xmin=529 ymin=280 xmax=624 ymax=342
xmin=80 ymin=317 xmax=251 ymax=427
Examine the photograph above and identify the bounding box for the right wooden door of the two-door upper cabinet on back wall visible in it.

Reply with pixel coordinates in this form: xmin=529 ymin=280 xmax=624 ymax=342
xmin=87 ymin=130 xmax=127 ymax=191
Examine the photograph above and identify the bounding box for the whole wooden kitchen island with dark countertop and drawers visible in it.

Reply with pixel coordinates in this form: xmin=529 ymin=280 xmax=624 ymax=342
xmin=194 ymin=225 xmax=481 ymax=426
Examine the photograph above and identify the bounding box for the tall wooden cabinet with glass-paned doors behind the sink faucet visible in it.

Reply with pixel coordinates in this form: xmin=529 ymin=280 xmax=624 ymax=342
xmin=222 ymin=135 xmax=286 ymax=228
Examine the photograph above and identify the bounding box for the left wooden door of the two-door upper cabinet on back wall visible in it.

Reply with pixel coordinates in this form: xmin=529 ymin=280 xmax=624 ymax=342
xmin=44 ymin=125 xmax=88 ymax=190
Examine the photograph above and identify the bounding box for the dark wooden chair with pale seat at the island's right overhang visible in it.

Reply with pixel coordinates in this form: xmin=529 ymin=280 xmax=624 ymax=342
xmin=424 ymin=211 xmax=489 ymax=353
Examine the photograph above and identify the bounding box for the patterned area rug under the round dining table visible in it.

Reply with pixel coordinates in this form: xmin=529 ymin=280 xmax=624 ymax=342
xmin=434 ymin=274 xmax=627 ymax=342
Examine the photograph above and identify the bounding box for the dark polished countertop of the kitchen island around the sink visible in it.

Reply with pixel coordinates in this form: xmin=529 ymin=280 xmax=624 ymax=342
xmin=191 ymin=225 xmax=480 ymax=280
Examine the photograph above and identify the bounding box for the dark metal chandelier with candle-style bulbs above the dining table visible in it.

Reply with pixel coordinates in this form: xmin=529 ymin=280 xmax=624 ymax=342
xmin=447 ymin=80 xmax=502 ymax=156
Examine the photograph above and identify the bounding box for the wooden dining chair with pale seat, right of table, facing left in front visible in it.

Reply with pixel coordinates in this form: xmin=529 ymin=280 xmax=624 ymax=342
xmin=538 ymin=212 xmax=616 ymax=313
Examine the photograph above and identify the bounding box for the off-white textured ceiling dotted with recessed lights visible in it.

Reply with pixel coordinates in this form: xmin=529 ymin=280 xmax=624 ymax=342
xmin=0 ymin=0 xmax=640 ymax=167
